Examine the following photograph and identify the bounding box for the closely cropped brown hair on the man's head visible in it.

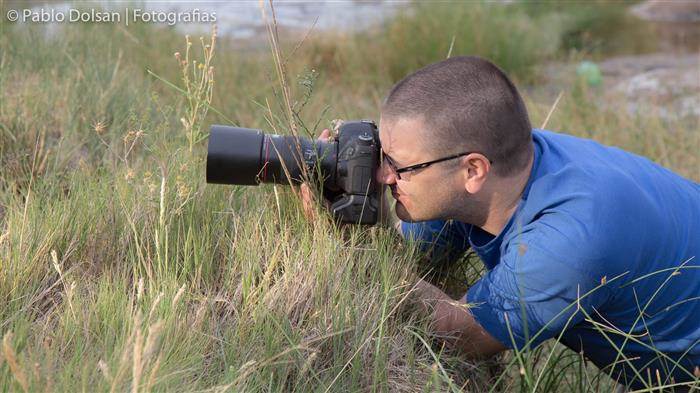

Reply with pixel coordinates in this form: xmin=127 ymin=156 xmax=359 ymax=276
xmin=382 ymin=56 xmax=532 ymax=176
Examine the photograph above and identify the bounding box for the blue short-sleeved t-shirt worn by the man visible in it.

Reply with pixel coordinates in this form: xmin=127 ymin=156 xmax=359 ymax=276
xmin=401 ymin=130 xmax=700 ymax=387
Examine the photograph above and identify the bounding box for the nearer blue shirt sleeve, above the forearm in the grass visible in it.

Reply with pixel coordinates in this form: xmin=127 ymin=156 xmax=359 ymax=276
xmin=466 ymin=227 xmax=610 ymax=349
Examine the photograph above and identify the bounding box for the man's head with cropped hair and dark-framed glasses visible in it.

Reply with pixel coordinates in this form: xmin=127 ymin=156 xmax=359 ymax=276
xmin=378 ymin=57 xmax=533 ymax=224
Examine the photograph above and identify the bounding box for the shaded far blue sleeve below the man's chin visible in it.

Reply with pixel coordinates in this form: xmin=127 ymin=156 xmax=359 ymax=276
xmin=401 ymin=220 xmax=469 ymax=265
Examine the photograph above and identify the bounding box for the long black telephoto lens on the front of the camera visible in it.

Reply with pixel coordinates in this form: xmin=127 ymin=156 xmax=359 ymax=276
xmin=207 ymin=125 xmax=338 ymax=185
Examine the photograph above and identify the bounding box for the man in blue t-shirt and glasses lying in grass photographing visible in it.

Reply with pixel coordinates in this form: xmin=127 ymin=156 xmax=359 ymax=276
xmin=302 ymin=57 xmax=700 ymax=388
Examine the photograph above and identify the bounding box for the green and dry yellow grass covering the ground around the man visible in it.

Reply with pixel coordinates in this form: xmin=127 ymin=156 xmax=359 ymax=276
xmin=0 ymin=4 xmax=700 ymax=392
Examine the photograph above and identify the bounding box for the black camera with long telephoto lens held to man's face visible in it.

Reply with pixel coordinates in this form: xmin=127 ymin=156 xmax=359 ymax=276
xmin=206 ymin=120 xmax=380 ymax=225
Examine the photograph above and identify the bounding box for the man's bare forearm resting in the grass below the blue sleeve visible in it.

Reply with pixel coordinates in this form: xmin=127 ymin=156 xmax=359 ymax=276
xmin=414 ymin=280 xmax=507 ymax=358
